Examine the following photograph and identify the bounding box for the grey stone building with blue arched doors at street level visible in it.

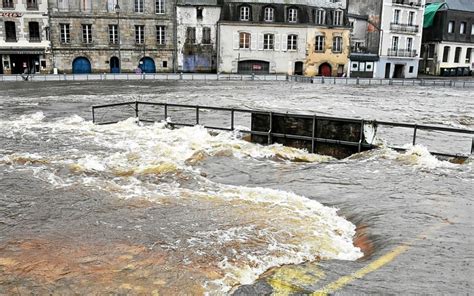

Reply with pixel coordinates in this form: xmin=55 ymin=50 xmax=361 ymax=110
xmin=49 ymin=0 xmax=175 ymax=73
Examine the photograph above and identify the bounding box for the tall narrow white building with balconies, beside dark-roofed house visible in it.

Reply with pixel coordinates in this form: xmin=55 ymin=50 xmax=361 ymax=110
xmin=374 ymin=0 xmax=425 ymax=78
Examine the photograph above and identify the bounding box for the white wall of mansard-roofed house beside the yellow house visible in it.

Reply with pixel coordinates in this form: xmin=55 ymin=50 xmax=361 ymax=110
xmin=218 ymin=24 xmax=306 ymax=74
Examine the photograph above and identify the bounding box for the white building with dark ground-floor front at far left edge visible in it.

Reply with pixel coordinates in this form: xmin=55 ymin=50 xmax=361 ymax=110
xmin=0 ymin=0 xmax=50 ymax=75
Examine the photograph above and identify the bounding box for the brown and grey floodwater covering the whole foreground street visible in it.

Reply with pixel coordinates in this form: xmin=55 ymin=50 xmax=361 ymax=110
xmin=0 ymin=81 xmax=474 ymax=295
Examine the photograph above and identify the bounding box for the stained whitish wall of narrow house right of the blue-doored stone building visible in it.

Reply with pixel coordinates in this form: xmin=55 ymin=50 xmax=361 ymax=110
xmin=176 ymin=6 xmax=221 ymax=70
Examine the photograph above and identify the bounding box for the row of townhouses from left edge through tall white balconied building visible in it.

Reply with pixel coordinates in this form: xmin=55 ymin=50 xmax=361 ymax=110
xmin=0 ymin=0 xmax=474 ymax=78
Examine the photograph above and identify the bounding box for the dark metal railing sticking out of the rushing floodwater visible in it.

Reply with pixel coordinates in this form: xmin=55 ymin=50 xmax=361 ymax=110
xmin=91 ymin=101 xmax=474 ymax=158
